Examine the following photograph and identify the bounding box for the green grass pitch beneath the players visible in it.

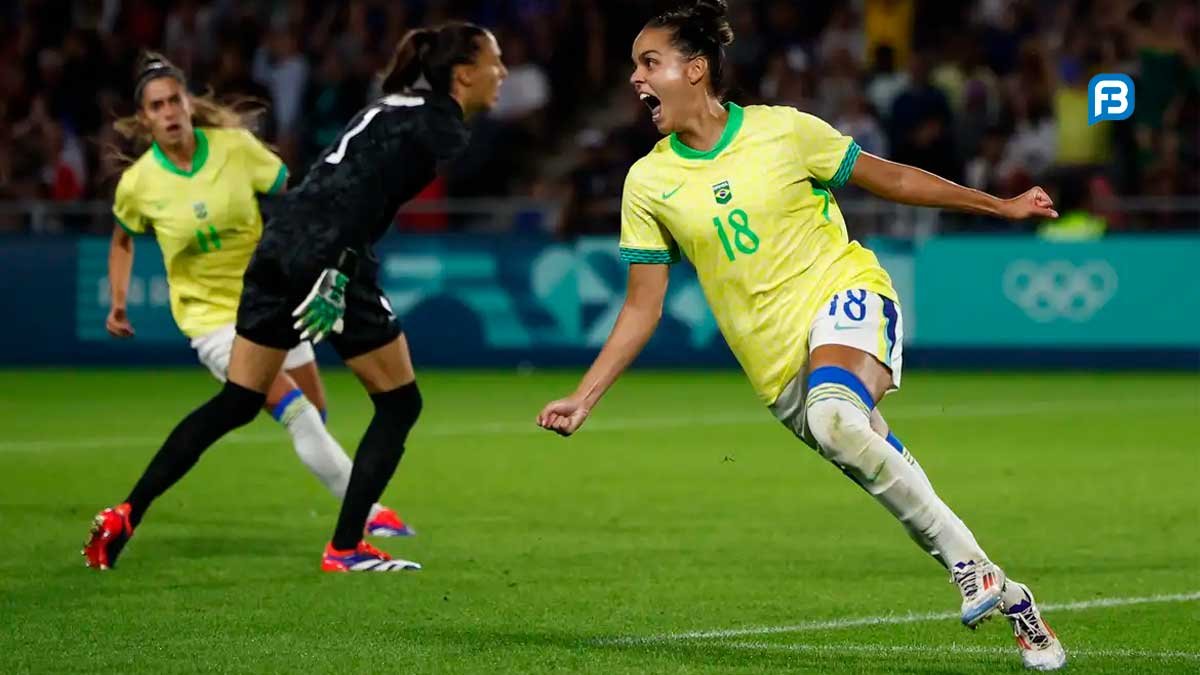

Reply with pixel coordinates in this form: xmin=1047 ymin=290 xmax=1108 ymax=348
xmin=0 ymin=366 xmax=1200 ymax=675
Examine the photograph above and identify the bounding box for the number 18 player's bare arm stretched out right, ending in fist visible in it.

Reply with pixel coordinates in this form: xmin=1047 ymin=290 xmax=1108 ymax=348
xmin=850 ymin=153 xmax=1058 ymax=220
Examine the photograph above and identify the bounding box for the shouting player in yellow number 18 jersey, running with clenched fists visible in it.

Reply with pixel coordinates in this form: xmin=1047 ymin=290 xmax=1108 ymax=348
xmin=538 ymin=0 xmax=1066 ymax=670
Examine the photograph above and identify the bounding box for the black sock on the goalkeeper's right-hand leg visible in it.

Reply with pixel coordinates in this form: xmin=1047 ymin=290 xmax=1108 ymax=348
xmin=334 ymin=382 xmax=421 ymax=550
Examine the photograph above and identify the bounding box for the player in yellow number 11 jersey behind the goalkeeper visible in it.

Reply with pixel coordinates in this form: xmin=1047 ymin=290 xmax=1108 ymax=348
xmin=99 ymin=53 xmax=412 ymax=537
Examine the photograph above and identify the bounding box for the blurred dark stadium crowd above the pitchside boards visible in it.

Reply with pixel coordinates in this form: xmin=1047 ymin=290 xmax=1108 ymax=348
xmin=0 ymin=0 xmax=1200 ymax=235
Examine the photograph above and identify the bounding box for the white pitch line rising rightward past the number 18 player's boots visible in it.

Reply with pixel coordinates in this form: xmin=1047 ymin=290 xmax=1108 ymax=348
xmin=604 ymin=591 xmax=1200 ymax=645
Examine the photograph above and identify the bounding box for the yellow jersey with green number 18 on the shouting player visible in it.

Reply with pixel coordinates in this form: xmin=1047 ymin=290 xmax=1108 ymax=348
xmin=620 ymin=103 xmax=896 ymax=404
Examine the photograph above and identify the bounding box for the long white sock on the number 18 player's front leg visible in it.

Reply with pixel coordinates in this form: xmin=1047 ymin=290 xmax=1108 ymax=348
xmin=805 ymin=383 xmax=986 ymax=567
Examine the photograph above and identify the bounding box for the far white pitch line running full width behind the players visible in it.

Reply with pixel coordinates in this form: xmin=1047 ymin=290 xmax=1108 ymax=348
xmin=0 ymin=398 xmax=1200 ymax=453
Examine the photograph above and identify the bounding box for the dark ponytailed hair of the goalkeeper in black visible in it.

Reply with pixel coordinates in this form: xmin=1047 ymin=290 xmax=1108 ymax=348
xmin=380 ymin=22 xmax=487 ymax=94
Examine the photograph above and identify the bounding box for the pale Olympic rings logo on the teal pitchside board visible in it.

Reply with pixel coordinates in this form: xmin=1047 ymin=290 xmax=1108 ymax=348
xmin=1003 ymin=259 xmax=1117 ymax=323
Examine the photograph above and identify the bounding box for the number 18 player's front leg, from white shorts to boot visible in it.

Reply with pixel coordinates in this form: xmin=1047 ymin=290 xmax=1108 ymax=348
xmin=772 ymin=289 xmax=1004 ymax=627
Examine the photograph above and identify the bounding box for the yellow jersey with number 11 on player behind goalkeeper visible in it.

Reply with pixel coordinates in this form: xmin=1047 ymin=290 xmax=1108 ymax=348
xmin=113 ymin=129 xmax=288 ymax=338
